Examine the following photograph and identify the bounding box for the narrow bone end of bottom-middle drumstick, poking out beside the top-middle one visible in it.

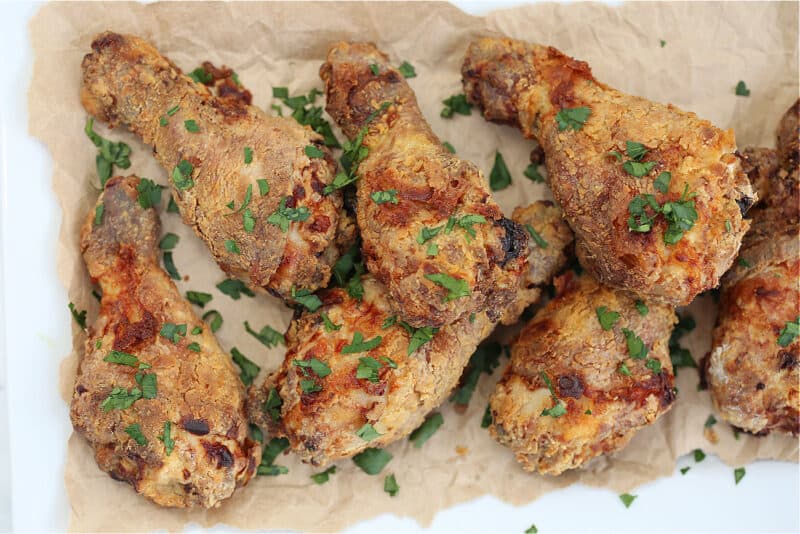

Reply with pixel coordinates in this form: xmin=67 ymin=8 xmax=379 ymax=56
xmin=500 ymin=200 xmax=575 ymax=325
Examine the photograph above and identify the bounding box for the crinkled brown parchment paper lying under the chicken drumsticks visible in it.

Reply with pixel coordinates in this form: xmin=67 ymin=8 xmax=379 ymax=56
xmin=29 ymin=2 xmax=798 ymax=531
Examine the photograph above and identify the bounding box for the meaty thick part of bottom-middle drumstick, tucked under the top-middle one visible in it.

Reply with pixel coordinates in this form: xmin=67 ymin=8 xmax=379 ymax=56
xmin=248 ymin=275 xmax=495 ymax=466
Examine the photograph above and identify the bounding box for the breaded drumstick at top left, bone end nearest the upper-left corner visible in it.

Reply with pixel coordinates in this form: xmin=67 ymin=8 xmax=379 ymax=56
xmin=81 ymin=32 xmax=342 ymax=298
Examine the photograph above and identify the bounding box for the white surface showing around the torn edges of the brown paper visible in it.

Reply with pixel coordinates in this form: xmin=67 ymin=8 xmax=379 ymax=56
xmin=0 ymin=1 xmax=800 ymax=534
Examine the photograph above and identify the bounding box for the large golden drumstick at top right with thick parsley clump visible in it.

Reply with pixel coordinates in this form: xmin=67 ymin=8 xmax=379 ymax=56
xmin=461 ymin=38 xmax=755 ymax=306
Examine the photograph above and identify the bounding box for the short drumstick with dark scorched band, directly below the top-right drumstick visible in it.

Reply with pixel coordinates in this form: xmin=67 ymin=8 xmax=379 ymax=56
xmin=489 ymin=272 xmax=677 ymax=475
